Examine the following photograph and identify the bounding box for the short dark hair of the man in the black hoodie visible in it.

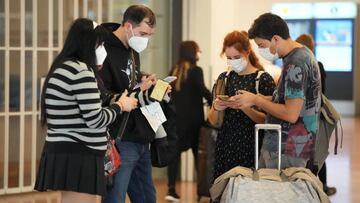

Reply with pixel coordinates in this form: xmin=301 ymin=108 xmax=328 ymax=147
xmin=122 ymin=5 xmax=156 ymax=28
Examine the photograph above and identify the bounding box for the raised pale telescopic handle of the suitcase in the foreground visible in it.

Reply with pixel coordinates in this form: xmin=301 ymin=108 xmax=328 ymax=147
xmin=255 ymin=124 xmax=281 ymax=170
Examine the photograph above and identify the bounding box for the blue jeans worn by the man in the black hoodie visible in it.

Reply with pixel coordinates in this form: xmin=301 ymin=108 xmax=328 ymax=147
xmin=103 ymin=141 xmax=156 ymax=203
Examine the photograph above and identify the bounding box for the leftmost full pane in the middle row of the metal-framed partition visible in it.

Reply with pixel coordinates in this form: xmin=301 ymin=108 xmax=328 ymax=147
xmin=9 ymin=51 xmax=20 ymax=111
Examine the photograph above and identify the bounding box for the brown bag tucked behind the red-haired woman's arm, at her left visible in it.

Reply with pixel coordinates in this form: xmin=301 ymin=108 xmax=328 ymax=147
xmin=212 ymin=70 xmax=231 ymax=128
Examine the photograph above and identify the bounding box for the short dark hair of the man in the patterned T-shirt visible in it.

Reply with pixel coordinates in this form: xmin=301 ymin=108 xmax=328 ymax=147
xmin=248 ymin=13 xmax=290 ymax=41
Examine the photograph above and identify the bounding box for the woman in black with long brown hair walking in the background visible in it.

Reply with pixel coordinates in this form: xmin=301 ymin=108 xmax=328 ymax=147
xmin=165 ymin=41 xmax=212 ymax=202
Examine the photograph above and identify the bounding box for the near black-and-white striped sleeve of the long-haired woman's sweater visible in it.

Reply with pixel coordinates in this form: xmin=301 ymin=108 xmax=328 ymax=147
xmin=72 ymin=70 xmax=121 ymax=129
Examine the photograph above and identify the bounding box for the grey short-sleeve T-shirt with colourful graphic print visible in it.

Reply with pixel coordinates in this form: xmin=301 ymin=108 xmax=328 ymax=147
xmin=263 ymin=47 xmax=321 ymax=159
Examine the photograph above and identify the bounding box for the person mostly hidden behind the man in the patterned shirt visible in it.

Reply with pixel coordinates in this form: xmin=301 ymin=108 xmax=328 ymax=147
xmin=296 ymin=34 xmax=336 ymax=196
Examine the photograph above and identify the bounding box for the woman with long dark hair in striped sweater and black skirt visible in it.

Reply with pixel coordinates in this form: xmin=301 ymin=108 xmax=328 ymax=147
xmin=35 ymin=18 xmax=137 ymax=202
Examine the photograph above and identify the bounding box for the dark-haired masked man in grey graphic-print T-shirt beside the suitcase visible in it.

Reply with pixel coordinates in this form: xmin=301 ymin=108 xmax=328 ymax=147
xmin=233 ymin=13 xmax=321 ymax=168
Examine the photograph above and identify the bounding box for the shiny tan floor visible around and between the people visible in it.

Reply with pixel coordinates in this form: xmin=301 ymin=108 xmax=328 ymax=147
xmin=0 ymin=117 xmax=360 ymax=203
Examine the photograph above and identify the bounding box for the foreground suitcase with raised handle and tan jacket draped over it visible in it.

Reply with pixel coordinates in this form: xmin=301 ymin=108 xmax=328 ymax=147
xmin=210 ymin=124 xmax=330 ymax=203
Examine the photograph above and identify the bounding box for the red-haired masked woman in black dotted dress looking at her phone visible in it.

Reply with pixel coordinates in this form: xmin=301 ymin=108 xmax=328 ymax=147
xmin=208 ymin=31 xmax=275 ymax=180
